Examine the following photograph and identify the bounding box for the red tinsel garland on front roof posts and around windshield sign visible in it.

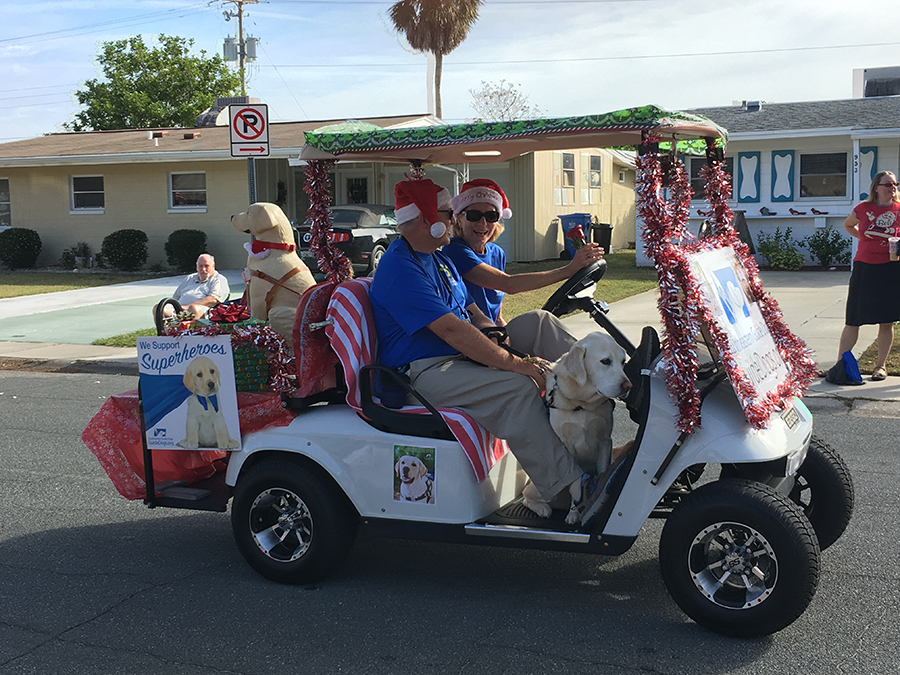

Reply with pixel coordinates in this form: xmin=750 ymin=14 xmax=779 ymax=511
xmin=635 ymin=139 xmax=816 ymax=432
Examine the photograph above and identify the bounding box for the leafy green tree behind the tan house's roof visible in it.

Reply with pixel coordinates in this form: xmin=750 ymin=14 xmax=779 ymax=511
xmin=66 ymin=35 xmax=241 ymax=131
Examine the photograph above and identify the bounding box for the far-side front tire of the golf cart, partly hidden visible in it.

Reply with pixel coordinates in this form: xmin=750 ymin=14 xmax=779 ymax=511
xmin=790 ymin=436 xmax=854 ymax=551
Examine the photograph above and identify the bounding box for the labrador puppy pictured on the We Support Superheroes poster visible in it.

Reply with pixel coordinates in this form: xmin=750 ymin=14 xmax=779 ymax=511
xmin=177 ymin=356 xmax=240 ymax=450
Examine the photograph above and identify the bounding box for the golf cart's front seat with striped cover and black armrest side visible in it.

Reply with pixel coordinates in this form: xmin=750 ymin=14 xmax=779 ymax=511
xmin=325 ymin=277 xmax=508 ymax=481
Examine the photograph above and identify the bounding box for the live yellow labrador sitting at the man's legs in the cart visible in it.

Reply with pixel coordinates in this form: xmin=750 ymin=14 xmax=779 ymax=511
xmin=523 ymin=332 xmax=631 ymax=524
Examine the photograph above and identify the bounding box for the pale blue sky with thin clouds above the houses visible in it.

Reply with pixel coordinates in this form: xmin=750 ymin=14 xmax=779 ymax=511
xmin=0 ymin=0 xmax=900 ymax=142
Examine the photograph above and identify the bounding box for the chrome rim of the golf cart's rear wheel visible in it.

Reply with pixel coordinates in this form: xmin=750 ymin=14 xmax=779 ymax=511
xmin=250 ymin=488 xmax=313 ymax=562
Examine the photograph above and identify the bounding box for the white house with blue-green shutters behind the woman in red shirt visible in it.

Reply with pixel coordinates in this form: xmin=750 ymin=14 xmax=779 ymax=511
xmin=639 ymin=93 xmax=900 ymax=264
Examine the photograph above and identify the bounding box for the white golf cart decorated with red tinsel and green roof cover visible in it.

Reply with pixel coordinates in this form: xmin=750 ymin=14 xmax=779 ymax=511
xmin=88 ymin=107 xmax=853 ymax=636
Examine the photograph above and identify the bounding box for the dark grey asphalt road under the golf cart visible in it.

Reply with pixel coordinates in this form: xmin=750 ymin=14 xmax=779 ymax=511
xmin=0 ymin=371 xmax=900 ymax=675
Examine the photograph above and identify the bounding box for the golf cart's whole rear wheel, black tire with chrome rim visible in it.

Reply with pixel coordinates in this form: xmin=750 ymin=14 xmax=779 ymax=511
xmin=231 ymin=459 xmax=357 ymax=584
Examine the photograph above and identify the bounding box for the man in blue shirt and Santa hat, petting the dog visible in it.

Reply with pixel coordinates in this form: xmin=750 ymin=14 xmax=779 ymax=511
xmin=369 ymin=180 xmax=600 ymax=509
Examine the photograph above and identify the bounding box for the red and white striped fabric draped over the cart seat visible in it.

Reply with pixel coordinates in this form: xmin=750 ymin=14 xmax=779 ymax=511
xmin=325 ymin=277 xmax=509 ymax=482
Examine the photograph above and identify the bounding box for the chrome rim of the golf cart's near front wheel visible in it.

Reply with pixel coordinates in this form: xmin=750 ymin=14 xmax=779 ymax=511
xmin=688 ymin=522 xmax=778 ymax=609
